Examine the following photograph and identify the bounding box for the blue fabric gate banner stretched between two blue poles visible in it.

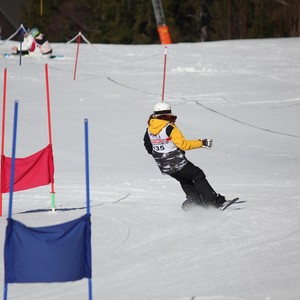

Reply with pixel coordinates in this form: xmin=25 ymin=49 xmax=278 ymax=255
xmin=4 ymin=214 xmax=92 ymax=283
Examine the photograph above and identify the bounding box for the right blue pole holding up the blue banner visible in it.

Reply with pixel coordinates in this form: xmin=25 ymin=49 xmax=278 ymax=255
xmin=84 ymin=119 xmax=93 ymax=300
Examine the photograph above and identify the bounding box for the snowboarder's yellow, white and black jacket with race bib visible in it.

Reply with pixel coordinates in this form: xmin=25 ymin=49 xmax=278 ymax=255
xmin=144 ymin=119 xmax=202 ymax=175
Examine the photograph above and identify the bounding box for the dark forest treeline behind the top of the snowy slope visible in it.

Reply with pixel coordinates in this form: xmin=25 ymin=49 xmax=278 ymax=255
xmin=20 ymin=0 xmax=300 ymax=44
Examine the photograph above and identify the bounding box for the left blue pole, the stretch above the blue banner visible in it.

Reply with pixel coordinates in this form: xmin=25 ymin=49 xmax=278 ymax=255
xmin=8 ymin=100 xmax=19 ymax=219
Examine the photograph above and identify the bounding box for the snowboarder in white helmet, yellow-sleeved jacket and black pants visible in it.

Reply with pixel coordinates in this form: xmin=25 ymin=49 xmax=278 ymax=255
xmin=144 ymin=102 xmax=226 ymax=210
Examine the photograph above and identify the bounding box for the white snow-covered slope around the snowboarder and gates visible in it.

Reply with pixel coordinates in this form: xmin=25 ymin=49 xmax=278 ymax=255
xmin=0 ymin=38 xmax=300 ymax=300
